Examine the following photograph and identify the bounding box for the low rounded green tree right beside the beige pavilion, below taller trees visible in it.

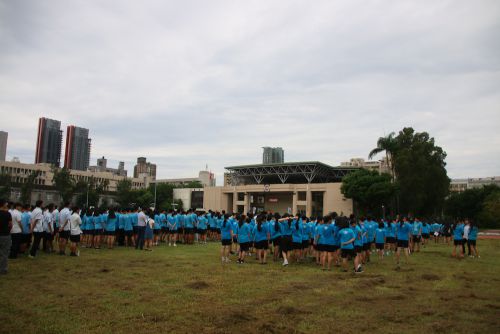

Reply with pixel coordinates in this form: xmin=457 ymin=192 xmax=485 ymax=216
xmin=341 ymin=169 xmax=396 ymax=215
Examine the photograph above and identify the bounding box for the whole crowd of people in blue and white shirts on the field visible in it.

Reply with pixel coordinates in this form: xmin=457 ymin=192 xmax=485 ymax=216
xmin=0 ymin=196 xmax=479 ymax=273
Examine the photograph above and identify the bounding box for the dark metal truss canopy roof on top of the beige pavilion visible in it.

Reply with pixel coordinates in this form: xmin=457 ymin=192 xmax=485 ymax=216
xmin=226 ymin=161 xmax=359 ymax=185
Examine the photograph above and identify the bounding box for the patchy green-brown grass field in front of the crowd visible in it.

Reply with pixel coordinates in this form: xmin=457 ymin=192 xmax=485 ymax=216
xmin=0 ymin=240 xmax=500 ymax=334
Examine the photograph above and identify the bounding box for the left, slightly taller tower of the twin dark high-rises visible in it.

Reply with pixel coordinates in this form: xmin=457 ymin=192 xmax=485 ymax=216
xmin=35 ymin=117 xmax=62 ymax=167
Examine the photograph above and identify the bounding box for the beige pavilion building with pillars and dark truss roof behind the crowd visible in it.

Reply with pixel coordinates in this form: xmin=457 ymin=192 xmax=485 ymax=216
xmin=203 ymin=162 xmax=357 ymax=217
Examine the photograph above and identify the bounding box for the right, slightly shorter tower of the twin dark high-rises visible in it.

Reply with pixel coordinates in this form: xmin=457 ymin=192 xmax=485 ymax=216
xmin=64 ymin=125 xmax=90 ymax=170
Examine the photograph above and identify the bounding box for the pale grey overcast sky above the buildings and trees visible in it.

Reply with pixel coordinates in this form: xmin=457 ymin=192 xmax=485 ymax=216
xmin=0 ymin=0 xmax=500 ymax=184
